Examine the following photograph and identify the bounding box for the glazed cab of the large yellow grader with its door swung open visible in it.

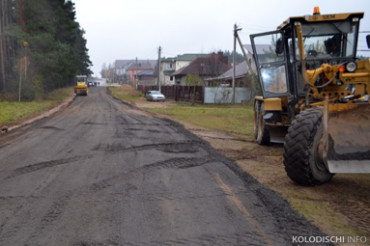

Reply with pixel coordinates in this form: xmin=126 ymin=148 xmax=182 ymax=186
xmin=251 ymin=14 xmax=362 ymax=98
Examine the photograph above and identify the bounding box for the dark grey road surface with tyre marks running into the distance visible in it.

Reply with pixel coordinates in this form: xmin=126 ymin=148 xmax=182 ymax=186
xmin=0 ymin=88 xmax=322 ymax=245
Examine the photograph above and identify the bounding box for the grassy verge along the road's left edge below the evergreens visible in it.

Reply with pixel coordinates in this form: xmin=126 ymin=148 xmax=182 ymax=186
xmin=0 ymin=87 xmax=73 ymax=125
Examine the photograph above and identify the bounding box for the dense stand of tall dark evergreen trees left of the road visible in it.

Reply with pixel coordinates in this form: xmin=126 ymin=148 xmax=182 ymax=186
xmin=0 ymin=0 xmax=91 ymax=100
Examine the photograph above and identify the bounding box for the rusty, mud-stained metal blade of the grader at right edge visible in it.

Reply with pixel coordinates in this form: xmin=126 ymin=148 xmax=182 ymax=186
xmin=324 ymin=104 xmax=370 ymax=173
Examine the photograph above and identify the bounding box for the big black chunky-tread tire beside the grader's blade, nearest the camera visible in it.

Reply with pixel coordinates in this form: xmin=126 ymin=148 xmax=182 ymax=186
xmin=284 ymin=109 xmax=333 ymax=186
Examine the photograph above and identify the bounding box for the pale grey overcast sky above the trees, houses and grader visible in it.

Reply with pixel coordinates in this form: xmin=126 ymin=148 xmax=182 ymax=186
xmin=73 ymin=0 xmax=370 ymax=75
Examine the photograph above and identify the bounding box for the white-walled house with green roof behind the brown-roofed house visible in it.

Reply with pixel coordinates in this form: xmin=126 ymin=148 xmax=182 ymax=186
xmin=160 ymin=54 xmax=208 ymax=85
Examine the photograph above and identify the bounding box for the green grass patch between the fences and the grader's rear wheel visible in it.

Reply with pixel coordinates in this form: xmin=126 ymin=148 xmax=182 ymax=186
xmin=146 ymin=105 xmax=253 ymax=137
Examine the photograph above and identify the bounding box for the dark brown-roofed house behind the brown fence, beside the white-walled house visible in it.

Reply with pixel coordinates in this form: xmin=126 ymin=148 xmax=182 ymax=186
xmin=171 ymin=52 xmax=230 ymax=85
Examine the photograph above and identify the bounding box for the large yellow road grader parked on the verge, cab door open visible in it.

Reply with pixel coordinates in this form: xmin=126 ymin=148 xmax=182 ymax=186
xmin=250 ymin=7 xmax=370 ymax=186
